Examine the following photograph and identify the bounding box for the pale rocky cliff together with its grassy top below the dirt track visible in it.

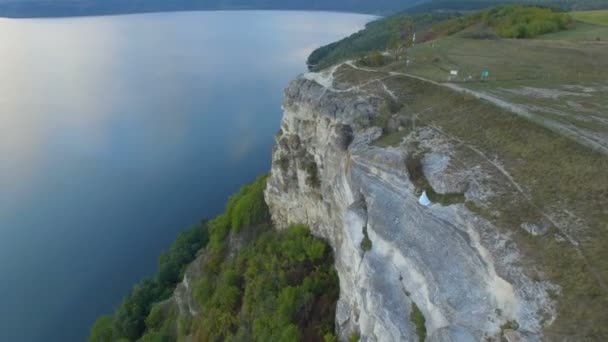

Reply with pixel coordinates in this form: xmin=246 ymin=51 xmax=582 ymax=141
xmin=265 ymin=64 xmax=608 ymax=341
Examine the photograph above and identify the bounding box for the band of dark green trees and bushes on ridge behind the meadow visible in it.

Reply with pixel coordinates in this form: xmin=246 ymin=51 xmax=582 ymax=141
xmin=308 ymin=5 xmax=572 ymax=70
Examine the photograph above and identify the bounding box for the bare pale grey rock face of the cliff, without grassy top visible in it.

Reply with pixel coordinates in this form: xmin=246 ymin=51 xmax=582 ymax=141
xmin=265 ymin=68 xmax=559 ymax=341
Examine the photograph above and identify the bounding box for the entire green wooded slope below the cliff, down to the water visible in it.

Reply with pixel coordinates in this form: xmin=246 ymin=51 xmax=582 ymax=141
xmin=89 ymin=176 xmax=339 ymax=342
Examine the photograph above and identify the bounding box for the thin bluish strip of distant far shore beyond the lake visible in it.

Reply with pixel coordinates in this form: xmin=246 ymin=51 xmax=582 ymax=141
xmin=0 ymin=0 xmax=606 ymax=19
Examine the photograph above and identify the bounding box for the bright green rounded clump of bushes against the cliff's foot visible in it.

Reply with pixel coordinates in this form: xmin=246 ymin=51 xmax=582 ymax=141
xmin=191 ymin=225 xmax=339 ymax=341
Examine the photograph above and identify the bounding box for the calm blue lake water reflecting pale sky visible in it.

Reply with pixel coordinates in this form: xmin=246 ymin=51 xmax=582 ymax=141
xmin=0 ymin=11 xmax=372 ymax=342
